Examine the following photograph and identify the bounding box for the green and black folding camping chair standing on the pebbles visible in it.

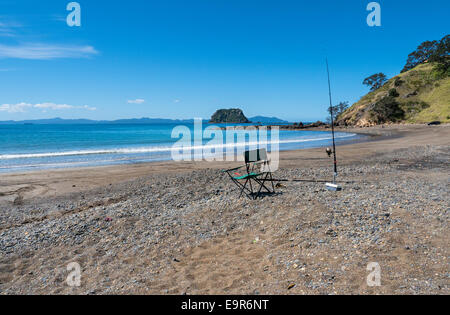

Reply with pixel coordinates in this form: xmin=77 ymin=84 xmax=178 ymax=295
xmin=223 ymin=149 xmax=275 ymax=200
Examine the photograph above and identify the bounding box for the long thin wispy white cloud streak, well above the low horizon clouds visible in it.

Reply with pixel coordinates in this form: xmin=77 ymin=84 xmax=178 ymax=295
xmin=0 ymin=44 xmax=98 ymax=60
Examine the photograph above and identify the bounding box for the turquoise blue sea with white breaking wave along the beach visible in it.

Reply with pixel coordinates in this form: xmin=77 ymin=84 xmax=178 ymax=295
xmin=0 ymin=124 xmax=359 ymax=172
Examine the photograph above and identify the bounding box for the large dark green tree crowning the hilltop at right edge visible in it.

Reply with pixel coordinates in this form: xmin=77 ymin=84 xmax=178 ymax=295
xmin=402 ymin=35 xmax=450 ymax=73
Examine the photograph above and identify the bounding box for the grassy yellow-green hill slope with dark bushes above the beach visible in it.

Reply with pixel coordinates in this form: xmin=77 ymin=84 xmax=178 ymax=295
xmin=337 ymin=63 xmax=450 ymax=126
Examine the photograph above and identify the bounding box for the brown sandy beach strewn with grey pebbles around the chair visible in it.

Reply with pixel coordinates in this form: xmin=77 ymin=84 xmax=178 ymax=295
xmin=0 ymin=124 xmax=450 ymax=294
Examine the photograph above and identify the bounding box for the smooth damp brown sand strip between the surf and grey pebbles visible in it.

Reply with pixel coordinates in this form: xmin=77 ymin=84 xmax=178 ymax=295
xmin=0 ymin=124 xmax=450 ymax=204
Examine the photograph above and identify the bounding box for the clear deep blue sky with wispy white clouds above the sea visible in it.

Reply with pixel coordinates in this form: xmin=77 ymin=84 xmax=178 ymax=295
xmin=0 ymin=0 xmax=450 ymax=121
